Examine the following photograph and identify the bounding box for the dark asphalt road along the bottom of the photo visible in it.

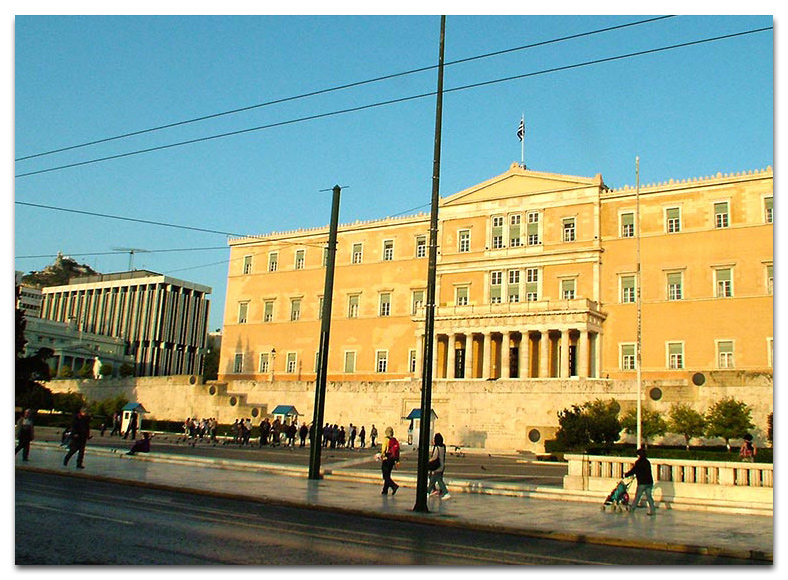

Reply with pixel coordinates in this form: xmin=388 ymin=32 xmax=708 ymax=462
xmin=15 ymin=471 xmax=754 ymax=566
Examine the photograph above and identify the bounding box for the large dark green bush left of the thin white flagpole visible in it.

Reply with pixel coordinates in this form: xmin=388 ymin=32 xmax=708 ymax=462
xmin=556 ymin=399 xmax=621 ymax=450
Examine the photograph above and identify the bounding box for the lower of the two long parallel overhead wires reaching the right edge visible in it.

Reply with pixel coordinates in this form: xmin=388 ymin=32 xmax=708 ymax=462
xmin=15 ymin=26 xmax=774 ymax=178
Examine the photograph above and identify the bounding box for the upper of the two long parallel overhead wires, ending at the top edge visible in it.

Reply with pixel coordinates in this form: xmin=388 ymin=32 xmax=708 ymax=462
xmin=14 ymin=15 xmax=675 ymax=161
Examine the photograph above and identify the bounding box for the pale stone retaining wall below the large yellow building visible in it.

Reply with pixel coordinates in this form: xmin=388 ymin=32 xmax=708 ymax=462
xmin=47 ymin=371 xmax=773 ymax=453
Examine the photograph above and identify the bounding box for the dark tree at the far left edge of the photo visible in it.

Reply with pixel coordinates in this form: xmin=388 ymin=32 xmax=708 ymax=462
xmin=14 ymin=286 xmax=54 ymax=409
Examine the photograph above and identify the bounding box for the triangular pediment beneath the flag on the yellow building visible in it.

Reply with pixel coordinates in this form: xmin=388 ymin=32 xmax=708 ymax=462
xmin=441 ymin=163 xmax=604 ymax=207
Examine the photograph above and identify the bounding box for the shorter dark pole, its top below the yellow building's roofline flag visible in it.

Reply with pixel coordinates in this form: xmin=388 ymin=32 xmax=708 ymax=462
xmin=309 ymin=185 xmax=341 ymax=479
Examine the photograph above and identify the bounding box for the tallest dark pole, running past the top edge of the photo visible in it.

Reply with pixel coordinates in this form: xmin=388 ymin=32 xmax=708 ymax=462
xmin=413 ymin=16 xmax=446 ymax=512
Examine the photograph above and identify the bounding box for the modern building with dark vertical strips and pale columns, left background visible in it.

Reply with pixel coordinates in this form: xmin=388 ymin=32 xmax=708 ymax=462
xmin=41 ymin=270 xmax=211 ymax=376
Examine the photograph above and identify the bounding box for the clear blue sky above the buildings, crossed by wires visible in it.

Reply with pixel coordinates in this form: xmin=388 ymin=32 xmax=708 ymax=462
xmin=13 ymin=11 xmax=774 ymax=329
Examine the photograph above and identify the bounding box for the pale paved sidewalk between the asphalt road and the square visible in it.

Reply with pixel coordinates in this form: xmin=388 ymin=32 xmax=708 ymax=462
xmin=15 ymin=442 xmax=774 ymax=561
